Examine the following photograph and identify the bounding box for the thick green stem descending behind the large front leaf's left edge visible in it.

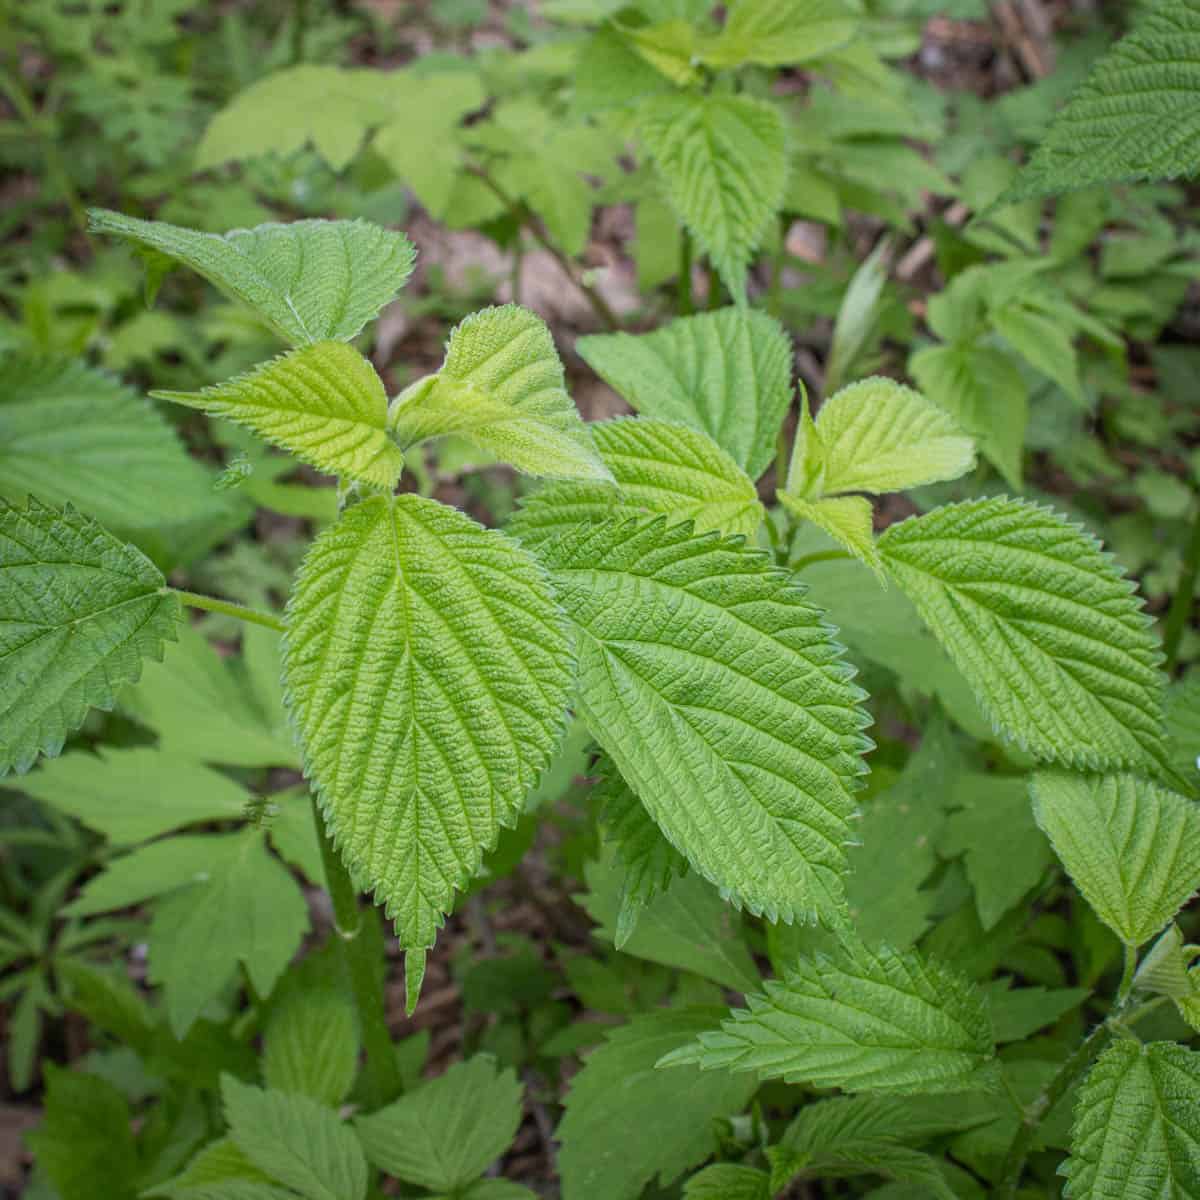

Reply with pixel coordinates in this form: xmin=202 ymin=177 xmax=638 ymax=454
xmin=312 ymin=798 xmax=403 ymax=1109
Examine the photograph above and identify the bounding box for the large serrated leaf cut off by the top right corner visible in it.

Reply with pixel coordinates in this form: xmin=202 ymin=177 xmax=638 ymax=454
xmin=1001 ymin=0 xmax=1200 ymax=203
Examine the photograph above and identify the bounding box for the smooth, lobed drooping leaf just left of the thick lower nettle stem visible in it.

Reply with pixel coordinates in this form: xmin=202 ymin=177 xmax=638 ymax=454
xmin=150 ymin=829 xmax=308 ymax=1036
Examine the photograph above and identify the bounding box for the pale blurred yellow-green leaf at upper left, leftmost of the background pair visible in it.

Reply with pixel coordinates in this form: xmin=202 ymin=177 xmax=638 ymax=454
xmin=196 ymin=62 xmax=388 ymax=170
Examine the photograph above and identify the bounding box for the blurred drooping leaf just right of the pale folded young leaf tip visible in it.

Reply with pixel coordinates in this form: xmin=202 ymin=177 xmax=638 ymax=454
xmin=908 ymin=344 xmax=1030 ymax=491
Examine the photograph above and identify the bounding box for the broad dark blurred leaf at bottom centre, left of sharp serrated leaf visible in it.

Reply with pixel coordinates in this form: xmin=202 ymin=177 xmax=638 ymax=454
xmin=557 ymin=1008 xmax=757 ymax=1200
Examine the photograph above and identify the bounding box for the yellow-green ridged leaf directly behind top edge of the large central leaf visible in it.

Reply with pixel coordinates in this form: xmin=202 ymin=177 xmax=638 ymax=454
xmin=508 ymin=418 xmax=763 ymax=547
